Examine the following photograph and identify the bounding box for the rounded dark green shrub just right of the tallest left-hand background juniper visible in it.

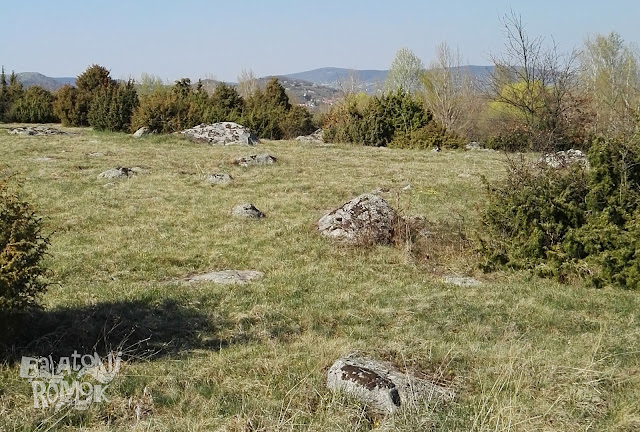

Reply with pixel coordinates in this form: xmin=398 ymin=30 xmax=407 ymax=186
xmin=87 ymin=81 xmax=138 ymax=131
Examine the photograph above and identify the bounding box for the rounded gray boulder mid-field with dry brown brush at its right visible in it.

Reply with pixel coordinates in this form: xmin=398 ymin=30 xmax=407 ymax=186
xmin=318 ymin=193 xmax=398 ymax=244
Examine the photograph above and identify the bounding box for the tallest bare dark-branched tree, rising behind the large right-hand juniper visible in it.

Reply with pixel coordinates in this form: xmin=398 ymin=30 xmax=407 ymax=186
xmin=489 ymin=11 xmax=577 ymax=148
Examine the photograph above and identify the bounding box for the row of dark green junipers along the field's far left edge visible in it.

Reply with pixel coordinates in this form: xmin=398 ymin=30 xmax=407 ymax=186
xmin=0 ymin=65 xmax=315 ymax=139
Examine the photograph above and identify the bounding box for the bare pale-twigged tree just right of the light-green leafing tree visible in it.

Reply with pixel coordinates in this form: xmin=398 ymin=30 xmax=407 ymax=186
xmin=421 ymin=42 xmax=480 ymax=135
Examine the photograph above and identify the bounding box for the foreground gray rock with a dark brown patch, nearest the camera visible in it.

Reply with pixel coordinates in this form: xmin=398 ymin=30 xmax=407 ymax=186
xmin=327 ymin=355 xmax=455 ymax=415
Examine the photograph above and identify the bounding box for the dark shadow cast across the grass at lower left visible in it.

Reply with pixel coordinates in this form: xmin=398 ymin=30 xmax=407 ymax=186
xmin=0 ymin=300 xmax=240 ymax=363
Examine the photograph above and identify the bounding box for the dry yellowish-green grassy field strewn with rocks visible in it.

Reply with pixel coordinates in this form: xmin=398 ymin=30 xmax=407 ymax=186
xmin=0 ymin=123 xmax=640 ymax=431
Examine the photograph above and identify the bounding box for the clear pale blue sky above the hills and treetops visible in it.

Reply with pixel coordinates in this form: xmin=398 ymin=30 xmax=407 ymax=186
xmin=0 ymin=0 xmax=640 ymax=81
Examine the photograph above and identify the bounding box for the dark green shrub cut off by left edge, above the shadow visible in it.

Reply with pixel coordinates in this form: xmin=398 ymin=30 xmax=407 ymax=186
xmin=0 ymin=179 xmax=49 ymax=316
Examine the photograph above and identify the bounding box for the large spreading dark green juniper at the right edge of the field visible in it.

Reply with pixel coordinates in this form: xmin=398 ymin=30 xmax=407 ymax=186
xmin=479 ymin=139 xmax=640 ymax=289
